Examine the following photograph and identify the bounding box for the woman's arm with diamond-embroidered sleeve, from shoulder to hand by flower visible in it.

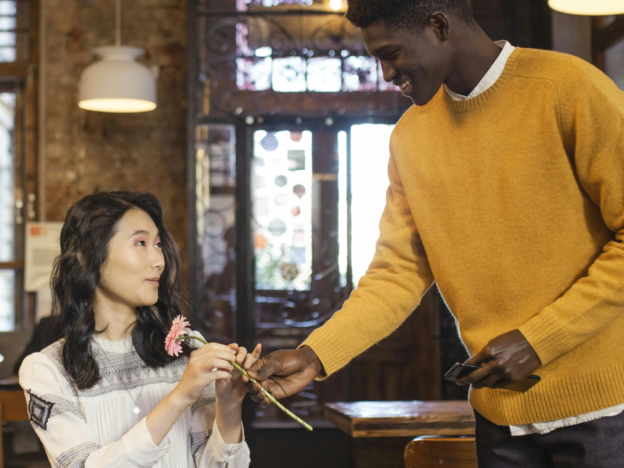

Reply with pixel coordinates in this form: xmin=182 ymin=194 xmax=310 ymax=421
xmin=20 ymin=345 xmax=235 ymax=468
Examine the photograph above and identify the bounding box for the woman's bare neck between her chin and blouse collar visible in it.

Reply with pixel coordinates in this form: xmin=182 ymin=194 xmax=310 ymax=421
xmin=93 ymin=288 xmax=136 ymax=341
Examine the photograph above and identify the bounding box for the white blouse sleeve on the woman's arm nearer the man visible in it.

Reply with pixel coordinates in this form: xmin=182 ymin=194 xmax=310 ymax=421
xmin=191 ymin=376 xmax=250 ymax=468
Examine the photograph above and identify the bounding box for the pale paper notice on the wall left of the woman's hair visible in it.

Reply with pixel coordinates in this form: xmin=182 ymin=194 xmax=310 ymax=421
xmin=24 ymin=223 xmax=63 ymax=292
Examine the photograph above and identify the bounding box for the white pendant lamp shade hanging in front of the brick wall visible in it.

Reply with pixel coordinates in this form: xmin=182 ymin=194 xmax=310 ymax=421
xmin=78 ymin=46 xmax=156 ymax=113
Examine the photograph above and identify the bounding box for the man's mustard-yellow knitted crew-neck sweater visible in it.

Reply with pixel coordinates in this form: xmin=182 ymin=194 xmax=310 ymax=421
xmin=304 ymin=48 xmax=624 ymax=425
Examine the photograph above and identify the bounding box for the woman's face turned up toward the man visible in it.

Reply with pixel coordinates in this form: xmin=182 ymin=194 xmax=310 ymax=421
xmin=97 ymin=209 xmax=165 ymax=308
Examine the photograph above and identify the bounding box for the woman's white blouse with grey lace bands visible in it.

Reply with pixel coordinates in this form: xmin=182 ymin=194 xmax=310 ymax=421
xmin=19 ymin=332 xmax=249 ymax=468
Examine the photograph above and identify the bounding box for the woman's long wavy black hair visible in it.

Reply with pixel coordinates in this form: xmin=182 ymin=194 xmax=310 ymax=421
xmin=51 ymin=192 xmax=189 ymax=389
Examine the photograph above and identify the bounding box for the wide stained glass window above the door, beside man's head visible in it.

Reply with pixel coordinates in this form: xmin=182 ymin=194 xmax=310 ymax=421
xmin=232 ymin=6 xmax=397 ymax=93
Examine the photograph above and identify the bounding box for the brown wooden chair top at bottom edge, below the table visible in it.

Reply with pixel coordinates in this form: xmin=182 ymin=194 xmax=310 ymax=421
xmin=405 ymin=436 xmax=477 ymax=468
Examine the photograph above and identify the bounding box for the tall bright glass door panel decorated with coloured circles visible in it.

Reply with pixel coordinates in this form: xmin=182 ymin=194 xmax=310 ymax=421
xmin=252 ymin=130 xmax=312 ymax=291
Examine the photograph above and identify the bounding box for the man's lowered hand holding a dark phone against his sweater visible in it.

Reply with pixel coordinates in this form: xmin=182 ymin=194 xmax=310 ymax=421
xmin=457 ymin=330 xmax=541 ymax=388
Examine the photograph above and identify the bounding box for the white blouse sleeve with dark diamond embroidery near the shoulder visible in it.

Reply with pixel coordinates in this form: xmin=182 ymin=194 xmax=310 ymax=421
xmin=19 ymin=353 xmax=169 ymax=468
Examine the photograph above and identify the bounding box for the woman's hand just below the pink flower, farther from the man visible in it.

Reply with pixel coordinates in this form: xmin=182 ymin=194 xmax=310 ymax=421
xmin=172 ymin=343 xmax=236 ymax=406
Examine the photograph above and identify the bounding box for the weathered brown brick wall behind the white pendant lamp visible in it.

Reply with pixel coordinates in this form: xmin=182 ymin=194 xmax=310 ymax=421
xmin=41 ymin=0 xmax=187 ymax=263
